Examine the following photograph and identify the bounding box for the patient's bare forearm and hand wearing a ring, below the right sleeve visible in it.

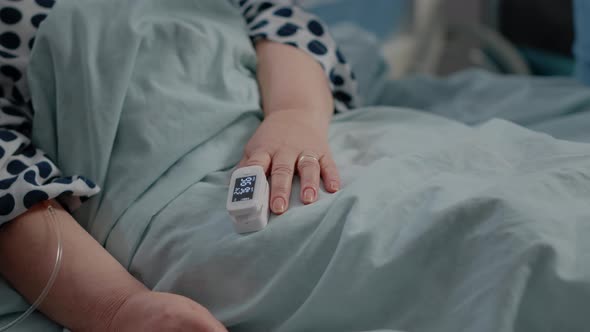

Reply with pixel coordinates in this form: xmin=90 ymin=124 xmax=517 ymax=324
xmin=249 ymin=40 xmax=340 ymax=214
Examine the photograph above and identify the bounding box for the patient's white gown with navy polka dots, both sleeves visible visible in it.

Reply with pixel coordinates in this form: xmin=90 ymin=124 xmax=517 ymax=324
xmin=0 ymin=0 xmax=357 ymax=225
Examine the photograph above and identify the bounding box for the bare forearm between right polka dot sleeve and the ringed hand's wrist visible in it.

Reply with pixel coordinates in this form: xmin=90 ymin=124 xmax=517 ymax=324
xmin=256 ymin=40 xmax=334 ymax=126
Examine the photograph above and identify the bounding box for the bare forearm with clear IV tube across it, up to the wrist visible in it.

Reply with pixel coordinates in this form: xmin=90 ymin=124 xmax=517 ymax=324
xmin=0 ymin=202 xmax=146 ymax=331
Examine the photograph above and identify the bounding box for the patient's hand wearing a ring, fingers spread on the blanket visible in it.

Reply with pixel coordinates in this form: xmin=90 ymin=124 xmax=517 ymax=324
xmin=240 ymin=110 xmax=340 ymax=214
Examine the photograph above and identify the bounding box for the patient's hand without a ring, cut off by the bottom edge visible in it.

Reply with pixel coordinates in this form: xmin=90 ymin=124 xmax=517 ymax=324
xmin=107 ymin=291 xmax=227 ymax=332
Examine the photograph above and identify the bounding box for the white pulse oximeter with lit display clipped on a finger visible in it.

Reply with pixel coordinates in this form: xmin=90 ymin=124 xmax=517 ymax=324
xmin=226 ymin=166 xmax=269 ymax=234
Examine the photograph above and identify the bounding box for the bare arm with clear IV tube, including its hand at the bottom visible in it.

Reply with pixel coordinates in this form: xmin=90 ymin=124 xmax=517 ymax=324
xmin=0 ymin=201 xmax=226 ymax=332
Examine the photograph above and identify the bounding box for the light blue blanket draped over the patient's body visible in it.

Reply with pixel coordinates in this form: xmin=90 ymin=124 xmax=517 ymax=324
xmin=0 ymin=0 xmax=590 ymax=332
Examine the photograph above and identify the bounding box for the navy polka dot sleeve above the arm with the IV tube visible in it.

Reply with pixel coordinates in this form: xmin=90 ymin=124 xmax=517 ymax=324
xmin=0 ymin=0 xmax=99 ymax=225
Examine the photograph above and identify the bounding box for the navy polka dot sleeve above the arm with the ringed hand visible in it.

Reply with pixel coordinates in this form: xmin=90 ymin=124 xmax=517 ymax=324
xmin=231 ymin=0 xmax=359 ymax=112
